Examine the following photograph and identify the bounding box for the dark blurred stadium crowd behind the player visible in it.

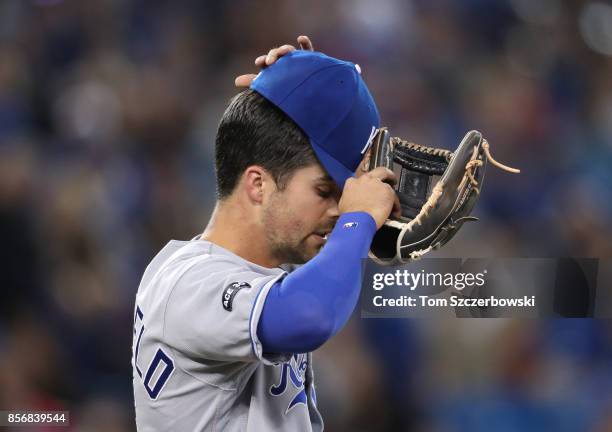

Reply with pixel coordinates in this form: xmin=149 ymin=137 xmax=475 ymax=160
xmin=0 ymin=0 xmax=612 ymax=432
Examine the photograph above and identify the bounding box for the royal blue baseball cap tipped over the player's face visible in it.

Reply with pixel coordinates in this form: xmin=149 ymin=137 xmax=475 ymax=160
xmin=251 ymin=50 xmax=380 ymax=189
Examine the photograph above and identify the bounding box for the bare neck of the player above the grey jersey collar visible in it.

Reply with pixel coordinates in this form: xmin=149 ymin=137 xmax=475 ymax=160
xmin=200 ymin=197 xmax=282 ymax=268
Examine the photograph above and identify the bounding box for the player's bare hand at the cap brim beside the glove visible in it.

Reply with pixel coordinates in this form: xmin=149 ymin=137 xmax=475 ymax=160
xmin=338 ymin=167 xmax=401 ymax=229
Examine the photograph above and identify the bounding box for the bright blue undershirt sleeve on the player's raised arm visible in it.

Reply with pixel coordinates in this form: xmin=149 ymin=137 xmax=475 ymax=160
xmin=257 ymin=212 xmax=376 ymax=353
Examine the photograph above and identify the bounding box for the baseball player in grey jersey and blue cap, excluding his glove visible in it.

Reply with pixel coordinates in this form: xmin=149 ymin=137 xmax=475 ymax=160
xmin=132 ymin=38 xmax=399 ymax=432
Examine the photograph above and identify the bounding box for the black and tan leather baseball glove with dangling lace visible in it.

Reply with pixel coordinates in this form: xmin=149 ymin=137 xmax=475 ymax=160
xmin=366 ymin=128 xmax=520 ymax=264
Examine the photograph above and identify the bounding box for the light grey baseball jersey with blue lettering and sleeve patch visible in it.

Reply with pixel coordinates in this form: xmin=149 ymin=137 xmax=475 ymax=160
xmin=132 ymin=240 xmax=323 ymax=432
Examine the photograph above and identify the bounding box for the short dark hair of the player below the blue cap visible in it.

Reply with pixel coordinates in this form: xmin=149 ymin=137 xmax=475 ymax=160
xmin=215 ymin=89 xmax=318 ymax=199
